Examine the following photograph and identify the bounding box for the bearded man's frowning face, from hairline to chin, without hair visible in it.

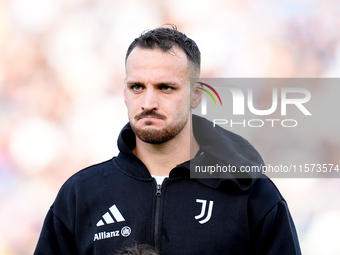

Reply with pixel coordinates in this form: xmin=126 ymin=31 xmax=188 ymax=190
xmin=124 ymin=47 xmax=191 ymax=144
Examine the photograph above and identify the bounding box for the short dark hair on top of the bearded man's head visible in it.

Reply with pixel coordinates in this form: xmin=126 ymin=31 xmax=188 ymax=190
xmin=125 ymin=25 xmax=201 ymax=74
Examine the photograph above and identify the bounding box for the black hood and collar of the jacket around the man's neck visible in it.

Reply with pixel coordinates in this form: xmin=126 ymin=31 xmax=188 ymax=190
xmin=116 ymin=115 xmax=264 ymax=191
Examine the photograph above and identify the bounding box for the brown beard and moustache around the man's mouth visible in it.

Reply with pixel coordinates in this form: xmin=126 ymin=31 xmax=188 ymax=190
xmin=130 ymin=111 xmax=189 ymax=144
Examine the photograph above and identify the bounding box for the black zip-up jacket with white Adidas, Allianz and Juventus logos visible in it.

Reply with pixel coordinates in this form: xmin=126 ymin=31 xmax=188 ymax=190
xmin=34 ymin=116 xmax=301 ymax=255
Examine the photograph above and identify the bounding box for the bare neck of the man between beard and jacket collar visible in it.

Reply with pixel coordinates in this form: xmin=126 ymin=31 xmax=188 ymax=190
xmin=132 ymin=127 xmax=199 ymax=176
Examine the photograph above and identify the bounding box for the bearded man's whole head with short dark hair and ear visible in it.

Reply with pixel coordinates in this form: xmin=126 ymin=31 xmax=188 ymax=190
xmin=124 ymin=28 xmax=201 ymax=144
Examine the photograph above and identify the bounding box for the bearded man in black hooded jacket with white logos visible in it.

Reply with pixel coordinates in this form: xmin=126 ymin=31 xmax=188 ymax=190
xmin=35 ymin=24 xmax=301 ymax=255
